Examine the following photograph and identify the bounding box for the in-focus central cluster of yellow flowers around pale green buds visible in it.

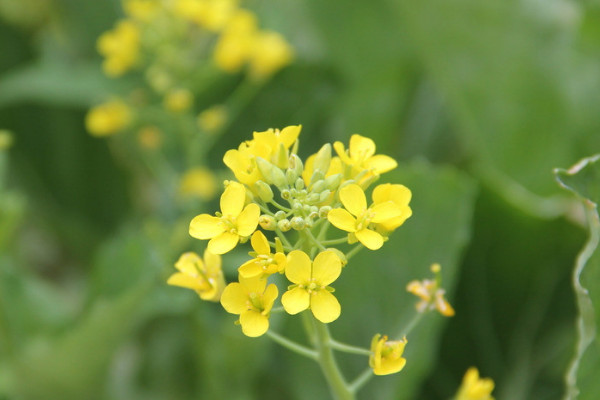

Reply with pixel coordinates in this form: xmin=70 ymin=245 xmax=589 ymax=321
xmin=171 ymin=126 xmax=411 ymax=338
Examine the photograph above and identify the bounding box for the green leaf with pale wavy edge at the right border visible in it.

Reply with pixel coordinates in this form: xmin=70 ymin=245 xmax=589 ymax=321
xmin=555 ymin=155 xmax=600 ymax=400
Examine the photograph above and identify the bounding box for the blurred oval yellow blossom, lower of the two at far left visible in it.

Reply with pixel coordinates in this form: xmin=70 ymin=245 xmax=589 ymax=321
xmin=85 ymin=100 xmax=131 ymax=136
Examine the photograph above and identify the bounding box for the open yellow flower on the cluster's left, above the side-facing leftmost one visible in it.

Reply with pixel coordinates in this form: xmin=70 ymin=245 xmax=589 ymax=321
xmin=190 ymin=182 xmax=260 ymax=254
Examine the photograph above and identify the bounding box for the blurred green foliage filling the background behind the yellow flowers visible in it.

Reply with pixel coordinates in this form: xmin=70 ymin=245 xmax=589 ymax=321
xmin=0 ymin=0 xmax=600 ymax=400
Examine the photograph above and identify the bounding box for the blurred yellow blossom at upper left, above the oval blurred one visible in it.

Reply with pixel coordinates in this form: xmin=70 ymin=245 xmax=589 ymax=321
xmin=97 ymin=20 xmax=140 ymax=77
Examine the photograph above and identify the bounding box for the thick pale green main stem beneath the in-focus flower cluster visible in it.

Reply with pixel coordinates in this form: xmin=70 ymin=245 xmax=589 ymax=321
xmin=313 ymin=318 xmax=354 ymax=400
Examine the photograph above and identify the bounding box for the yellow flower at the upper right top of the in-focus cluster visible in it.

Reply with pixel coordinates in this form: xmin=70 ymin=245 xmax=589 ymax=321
xmin=333 ymin=134 xmax=398 ymax=187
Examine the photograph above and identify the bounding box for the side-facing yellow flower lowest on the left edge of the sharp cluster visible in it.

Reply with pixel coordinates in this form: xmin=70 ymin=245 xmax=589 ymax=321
xmin=167 ymin=250 xmax=225 ymax=301
